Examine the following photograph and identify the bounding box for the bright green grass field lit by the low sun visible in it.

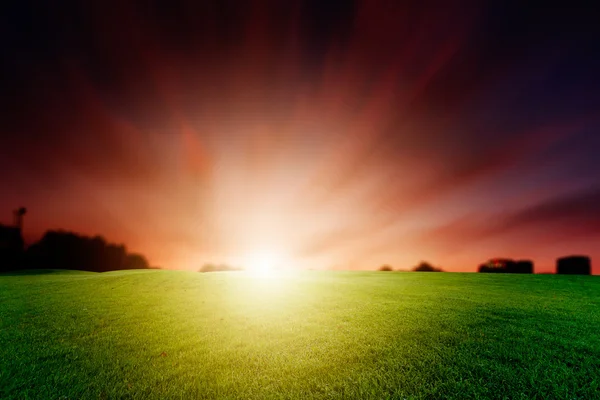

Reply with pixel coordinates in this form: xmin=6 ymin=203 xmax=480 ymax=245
xmin=0 ymin=271 xmax=600 ymax=399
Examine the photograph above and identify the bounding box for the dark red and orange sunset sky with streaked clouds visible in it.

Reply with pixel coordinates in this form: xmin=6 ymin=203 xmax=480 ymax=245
xmin=0 ymin=0 xmax=600 ymax=274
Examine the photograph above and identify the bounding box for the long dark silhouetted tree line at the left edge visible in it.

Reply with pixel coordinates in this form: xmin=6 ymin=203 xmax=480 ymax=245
xmin=0 ymin=226 xmax=150 ymax=272
